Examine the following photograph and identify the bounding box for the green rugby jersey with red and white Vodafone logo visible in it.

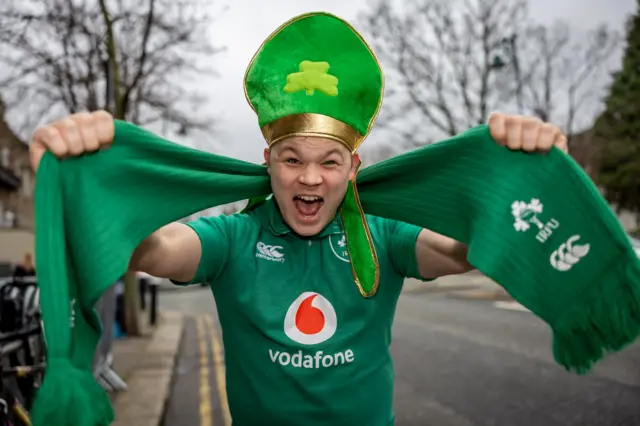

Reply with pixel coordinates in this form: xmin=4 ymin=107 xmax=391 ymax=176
xmin=181 ymin=198 xmax=430 ymax=426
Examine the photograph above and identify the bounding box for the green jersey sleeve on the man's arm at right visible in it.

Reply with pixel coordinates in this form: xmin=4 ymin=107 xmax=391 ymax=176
xmin=387 ymin=220 xmax=431 ymax=281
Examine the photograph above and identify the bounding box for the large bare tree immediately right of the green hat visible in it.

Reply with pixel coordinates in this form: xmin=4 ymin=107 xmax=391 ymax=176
xmin=362 ymin=0 xmax=526 ymax=145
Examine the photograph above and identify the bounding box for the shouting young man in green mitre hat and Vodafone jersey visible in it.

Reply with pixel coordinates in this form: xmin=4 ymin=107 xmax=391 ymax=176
xmin=31 ymin=13 xmax=566 ymax=426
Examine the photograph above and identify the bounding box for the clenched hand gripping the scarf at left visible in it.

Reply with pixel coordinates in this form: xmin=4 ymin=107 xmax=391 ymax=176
xmin=29 ymin=111 xmax=115 ymax=172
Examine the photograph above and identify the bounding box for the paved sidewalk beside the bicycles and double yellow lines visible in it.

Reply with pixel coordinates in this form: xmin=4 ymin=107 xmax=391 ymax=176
xmin=109 ymin=311 xmax=184 ymax=426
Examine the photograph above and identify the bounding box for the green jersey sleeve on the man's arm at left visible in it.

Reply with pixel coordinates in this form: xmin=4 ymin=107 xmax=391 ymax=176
xmin=174 ymin=215 xmax=230 ymax=285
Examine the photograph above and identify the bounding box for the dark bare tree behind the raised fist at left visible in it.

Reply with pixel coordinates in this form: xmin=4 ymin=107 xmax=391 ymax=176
xmin=0 ymin=0 xmax=221 ymax=140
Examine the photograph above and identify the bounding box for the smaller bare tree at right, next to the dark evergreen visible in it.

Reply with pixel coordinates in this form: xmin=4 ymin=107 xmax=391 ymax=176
xmin=499 ymin=22 xmax=621 ymax=144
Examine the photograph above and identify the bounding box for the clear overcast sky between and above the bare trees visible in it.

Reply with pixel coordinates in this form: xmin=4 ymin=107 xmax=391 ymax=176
xmin=175 ymin=0 xmax=635 ymax=162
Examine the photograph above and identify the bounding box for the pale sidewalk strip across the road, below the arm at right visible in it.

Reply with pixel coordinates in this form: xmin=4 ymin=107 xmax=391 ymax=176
xmin=402 ymin=271 xmax=512 ymax=301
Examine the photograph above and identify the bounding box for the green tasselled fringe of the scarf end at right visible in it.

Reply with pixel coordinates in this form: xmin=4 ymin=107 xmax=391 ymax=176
xmin=552 ymin=252 xmax=640 ymax=374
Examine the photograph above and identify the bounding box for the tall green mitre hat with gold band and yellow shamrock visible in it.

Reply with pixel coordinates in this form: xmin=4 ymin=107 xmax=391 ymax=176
xmin=244 ymin=12 xmax=384 ymax=152
